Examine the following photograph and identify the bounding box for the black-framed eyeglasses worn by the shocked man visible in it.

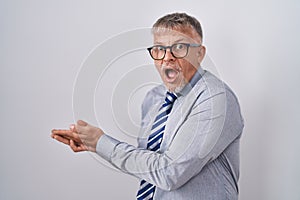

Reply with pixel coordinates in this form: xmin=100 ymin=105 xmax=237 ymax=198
xmin=147 ymin=43 xmax=201 ymax=60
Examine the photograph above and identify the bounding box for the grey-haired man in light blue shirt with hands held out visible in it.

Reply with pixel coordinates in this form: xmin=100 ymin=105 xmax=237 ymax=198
xmin=52 ymin=13 xmax=244 ymax=200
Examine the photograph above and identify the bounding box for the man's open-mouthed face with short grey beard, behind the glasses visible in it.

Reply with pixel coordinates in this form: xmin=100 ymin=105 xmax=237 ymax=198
xmin=154 ymin=27 xmax=205 ymax=92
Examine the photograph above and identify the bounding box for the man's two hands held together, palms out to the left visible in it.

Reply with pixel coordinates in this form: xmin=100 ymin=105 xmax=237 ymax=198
xmin=51 ymin=120 xmax=104 ymax=152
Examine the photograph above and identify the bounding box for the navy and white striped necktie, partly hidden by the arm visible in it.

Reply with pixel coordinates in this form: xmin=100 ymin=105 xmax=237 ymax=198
xmin=137 ymin=92 xmax=177 ymax=200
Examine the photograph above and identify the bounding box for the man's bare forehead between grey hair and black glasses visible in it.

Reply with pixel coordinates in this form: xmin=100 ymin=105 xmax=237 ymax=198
xmin=153 ymin=27 xmax=201 ymax=45
